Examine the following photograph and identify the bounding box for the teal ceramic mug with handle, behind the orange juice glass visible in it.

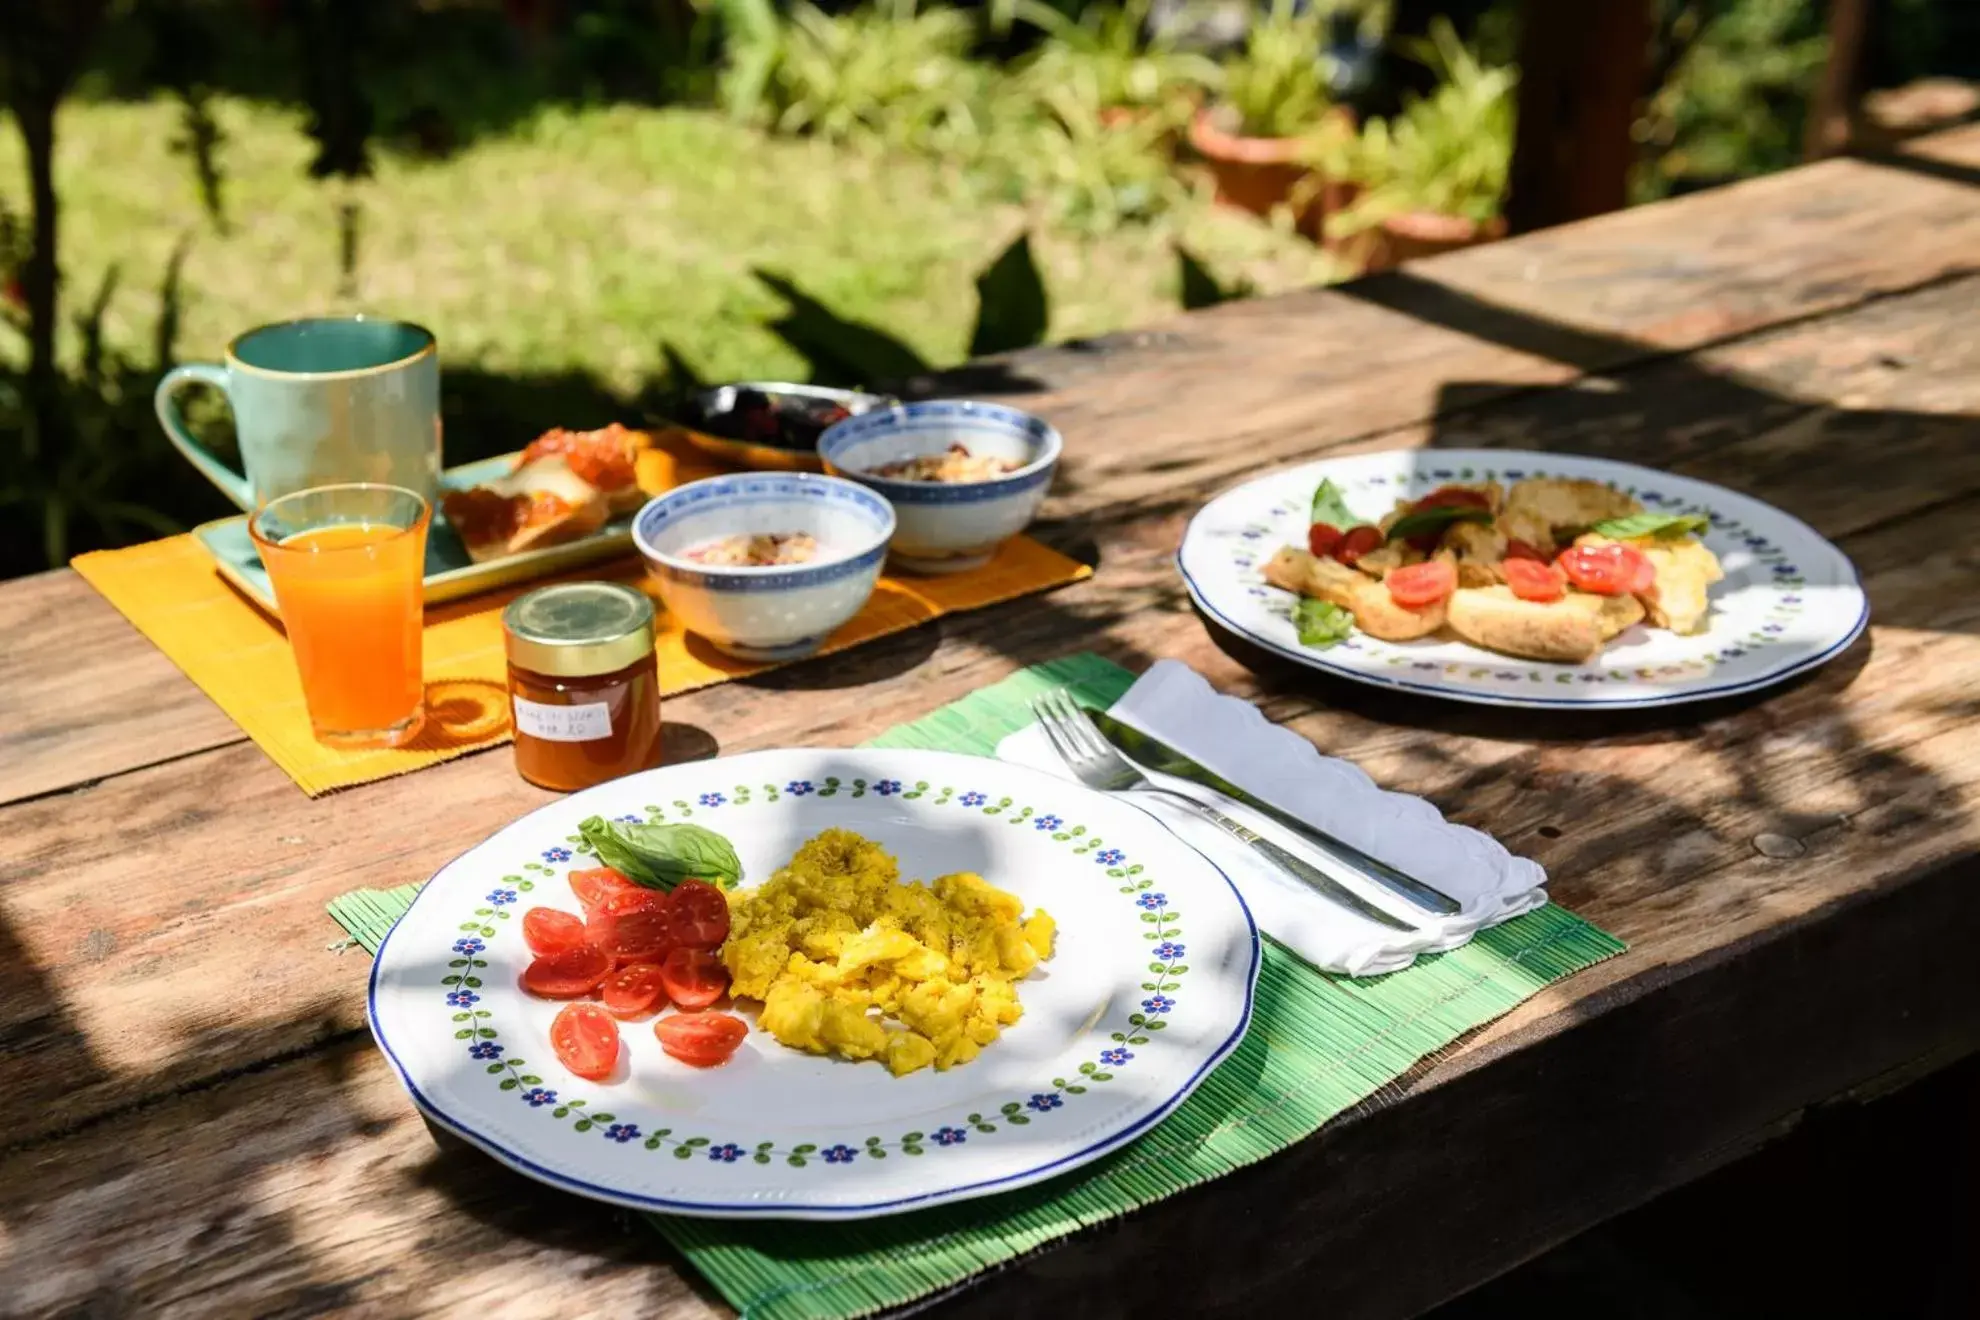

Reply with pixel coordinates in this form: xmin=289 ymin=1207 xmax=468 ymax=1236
xmin=154 ymin=317 xmax=440 ymax=511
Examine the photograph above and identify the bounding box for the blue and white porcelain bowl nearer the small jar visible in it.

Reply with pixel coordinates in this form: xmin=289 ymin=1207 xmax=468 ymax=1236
xmin=632 ymin=473 xmax=895 ymax=661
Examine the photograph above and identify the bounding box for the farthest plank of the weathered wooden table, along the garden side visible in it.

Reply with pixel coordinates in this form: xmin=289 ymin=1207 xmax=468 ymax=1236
xmin=11 ymin=127 xmax=1980 ymax=801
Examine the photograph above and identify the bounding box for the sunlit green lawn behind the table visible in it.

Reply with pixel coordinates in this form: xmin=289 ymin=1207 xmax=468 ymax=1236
xmin=0 ymin=99 xmax=1331 ymax=399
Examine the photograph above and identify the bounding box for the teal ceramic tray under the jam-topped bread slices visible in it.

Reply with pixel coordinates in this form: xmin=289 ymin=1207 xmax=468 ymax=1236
xmin=192 ymin=453 xmax=632 ymax=615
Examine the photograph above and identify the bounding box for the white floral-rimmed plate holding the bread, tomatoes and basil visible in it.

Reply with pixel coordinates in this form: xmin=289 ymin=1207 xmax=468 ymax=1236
xmin=1176 ymin=449 xmax=1869 ymax=708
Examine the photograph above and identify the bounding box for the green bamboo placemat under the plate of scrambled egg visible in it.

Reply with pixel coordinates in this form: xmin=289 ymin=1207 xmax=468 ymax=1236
xmin=329 ymin=655 xmax=1624 ymax=1320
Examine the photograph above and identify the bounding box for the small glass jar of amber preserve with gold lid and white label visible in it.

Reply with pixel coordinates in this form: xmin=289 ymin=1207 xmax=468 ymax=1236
xmin=501 ymin=582 xmax=659 ymax=794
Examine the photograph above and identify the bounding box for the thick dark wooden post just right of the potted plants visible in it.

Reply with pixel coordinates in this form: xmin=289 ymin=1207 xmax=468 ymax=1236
xmin=1507 ymin=0 xmax=1651 ymax=234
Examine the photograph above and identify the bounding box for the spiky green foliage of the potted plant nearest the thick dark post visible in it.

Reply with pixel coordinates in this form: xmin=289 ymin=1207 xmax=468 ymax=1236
xmin=1311 ymin=18 xmax=1519 ymax=237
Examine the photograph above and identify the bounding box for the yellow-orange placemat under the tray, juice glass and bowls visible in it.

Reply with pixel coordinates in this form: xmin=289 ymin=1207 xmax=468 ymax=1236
xmin=73 ymin=536 xmax=1093 ymax=798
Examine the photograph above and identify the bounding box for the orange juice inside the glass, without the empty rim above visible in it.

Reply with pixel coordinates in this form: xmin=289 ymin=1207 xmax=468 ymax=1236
xmin=261 ymin=522 xmax=426 ymax=744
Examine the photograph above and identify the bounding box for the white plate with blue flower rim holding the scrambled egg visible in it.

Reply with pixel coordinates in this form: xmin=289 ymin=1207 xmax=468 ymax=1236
xmin=368 ymin=750 xmax=1259 ymax=1219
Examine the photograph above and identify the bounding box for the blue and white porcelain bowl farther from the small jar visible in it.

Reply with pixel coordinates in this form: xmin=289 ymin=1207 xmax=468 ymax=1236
xmin=818 ymin=400 xmax=1063 ymax=572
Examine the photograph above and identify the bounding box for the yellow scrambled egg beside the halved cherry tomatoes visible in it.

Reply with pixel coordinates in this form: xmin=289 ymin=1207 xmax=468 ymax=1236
xmin=723 ymin=829 xmax=1055 ymax=1077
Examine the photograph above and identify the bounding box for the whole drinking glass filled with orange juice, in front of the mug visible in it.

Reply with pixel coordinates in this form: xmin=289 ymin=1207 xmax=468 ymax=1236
xmin=248 ymin=483 xmax=432 ymax=746
